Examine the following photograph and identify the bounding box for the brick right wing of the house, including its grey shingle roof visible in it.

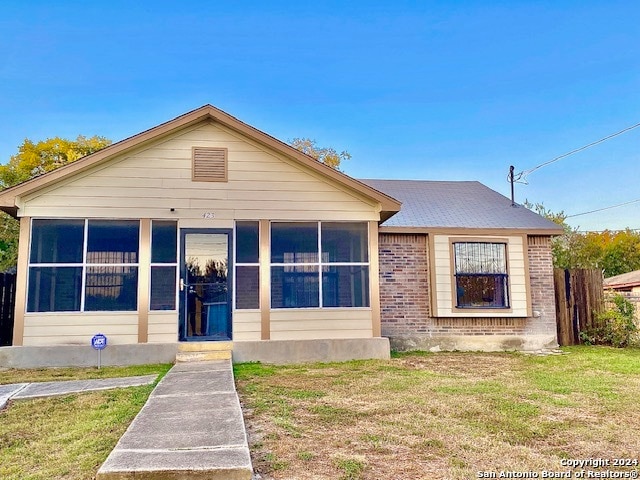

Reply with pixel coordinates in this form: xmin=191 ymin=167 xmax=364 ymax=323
xmin=363 ymin=180 xmax=562 ymax=350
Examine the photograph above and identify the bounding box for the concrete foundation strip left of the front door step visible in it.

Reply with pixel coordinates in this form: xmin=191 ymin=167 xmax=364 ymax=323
xmin=0 ymin=343 xmax=178 ymax=368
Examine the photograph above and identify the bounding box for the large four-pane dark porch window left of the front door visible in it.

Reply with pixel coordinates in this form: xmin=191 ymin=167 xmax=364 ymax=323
xmin=27 ymin=219 xmax=140 ymax=312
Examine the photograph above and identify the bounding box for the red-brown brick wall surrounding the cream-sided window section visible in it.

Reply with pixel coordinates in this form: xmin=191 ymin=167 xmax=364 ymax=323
xmin=379 ymin=233 xmax=556 ymax=338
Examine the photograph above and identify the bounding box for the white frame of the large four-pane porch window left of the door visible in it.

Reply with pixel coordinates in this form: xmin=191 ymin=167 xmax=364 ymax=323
xmin=25 ymin=217 xmax=140 ymax=315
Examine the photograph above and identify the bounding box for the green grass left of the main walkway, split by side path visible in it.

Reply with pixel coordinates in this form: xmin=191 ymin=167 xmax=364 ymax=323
xmin=0 ymin=365 xmax=171 ymax=480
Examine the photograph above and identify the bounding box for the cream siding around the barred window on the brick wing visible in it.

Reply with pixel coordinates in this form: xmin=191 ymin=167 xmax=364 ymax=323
xmin=433 ymin=235 xmax=528 ymax=317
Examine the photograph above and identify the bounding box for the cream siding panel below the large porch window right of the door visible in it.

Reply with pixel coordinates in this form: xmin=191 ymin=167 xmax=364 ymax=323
xmin=271 ymin=309 xmax=373 ymax=340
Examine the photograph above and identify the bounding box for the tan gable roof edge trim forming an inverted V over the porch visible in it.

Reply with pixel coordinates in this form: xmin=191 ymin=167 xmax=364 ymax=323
xmin=0 ymin=105 xmax=401 ymax=220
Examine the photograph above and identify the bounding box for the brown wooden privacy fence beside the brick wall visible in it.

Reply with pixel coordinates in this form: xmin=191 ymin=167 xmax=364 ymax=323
xmin=553 ymin=268 xmax=604 ymax=346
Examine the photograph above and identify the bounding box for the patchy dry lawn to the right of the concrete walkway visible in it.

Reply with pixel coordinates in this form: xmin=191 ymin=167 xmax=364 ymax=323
xmin=235 ymin=347 xmax=640 ymax=479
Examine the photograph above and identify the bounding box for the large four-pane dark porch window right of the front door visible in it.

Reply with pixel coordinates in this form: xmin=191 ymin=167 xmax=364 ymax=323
xmin=271 ymin=222 xmax=369 ymax=308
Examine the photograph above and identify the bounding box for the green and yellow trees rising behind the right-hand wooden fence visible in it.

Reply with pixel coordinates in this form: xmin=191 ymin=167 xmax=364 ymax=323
xmin=524 ymin=201 xmax=640 ymax=277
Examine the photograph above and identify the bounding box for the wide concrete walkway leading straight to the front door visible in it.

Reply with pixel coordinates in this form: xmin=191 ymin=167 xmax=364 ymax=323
xmin=96 ymin=360 xmax=252 ymax=480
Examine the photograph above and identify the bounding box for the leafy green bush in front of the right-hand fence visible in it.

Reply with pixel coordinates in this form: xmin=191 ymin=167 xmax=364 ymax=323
xmin=580 ymin=295 xmax=638 ymax=348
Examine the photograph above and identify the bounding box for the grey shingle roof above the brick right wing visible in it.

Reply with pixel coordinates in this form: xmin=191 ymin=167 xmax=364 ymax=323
xmin=360 ymin=179 xmax=562 ymax=235
